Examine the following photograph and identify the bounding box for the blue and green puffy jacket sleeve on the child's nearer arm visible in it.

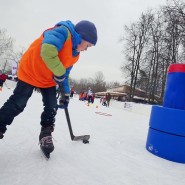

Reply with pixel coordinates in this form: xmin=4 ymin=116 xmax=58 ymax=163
xmin=41 ymin=26 xmax=70 ymax=76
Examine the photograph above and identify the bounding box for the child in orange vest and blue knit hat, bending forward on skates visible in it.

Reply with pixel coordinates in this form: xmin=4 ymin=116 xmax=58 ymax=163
xmin=0 ymin=20 xmax=97 ymax=158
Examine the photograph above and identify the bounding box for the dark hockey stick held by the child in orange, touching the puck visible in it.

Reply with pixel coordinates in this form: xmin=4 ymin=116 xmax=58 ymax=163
xmin=64 ymin=108 xmax=90 ymax=144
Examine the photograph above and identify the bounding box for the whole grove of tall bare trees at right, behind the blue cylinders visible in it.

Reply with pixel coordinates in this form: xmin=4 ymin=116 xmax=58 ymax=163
xmin=122 ymin=0 xmax=185 ymax=102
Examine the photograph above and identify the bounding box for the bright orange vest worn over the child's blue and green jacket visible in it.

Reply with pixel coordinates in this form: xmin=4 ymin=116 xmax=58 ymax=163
xmin=18 ymin=35 xmax=79 ymax=88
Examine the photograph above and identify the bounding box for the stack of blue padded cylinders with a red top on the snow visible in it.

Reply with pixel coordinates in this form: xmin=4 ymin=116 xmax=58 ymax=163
xmin=146 ymin=64 xmax=185 ymax=163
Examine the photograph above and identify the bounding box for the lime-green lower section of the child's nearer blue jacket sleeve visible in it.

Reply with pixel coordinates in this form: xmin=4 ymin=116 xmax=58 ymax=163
xmin=41 ymin=44 xmax=66 ymax=76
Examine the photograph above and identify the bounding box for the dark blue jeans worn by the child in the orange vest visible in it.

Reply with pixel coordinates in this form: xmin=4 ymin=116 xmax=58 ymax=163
xmin=0 ymin=80 xmax=58 ymax=133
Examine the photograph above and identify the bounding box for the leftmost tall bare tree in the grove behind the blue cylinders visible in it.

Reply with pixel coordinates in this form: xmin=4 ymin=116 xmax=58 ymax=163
xmin=122 ymin=11 xmax=153 ymax=101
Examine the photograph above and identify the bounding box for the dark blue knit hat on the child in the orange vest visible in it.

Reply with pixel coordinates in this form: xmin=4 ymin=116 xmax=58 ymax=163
xmin=75 ymin=20 xmax=97 ymax=45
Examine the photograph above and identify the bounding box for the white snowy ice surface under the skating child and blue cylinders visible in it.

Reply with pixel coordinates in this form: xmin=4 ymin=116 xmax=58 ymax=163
xmin=0 ymin=83 xmax=185 ymax=185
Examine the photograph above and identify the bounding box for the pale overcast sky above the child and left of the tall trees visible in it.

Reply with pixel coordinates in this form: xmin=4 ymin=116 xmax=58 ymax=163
xmin=0 ymin=0 xmax=166 ymax=83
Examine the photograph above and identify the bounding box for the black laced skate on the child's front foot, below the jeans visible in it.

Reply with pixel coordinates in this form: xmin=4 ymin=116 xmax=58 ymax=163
xmin=39 ymin=126 xmax=54 ymax=158
